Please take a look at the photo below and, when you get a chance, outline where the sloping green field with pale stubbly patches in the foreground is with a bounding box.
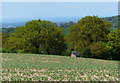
[1,53,119,81]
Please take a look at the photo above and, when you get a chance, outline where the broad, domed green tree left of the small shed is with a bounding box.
[4,20,65,54]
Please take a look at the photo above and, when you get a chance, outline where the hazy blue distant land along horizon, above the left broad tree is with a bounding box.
[0,17,81,28]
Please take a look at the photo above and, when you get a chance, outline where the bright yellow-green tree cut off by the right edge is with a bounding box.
[107,28,120,60]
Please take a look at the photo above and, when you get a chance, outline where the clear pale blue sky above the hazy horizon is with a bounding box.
[2,2,118,22]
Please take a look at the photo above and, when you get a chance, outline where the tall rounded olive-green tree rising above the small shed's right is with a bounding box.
[67,16,112,53]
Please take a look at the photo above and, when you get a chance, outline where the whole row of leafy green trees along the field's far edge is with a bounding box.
[2,16,120,60]
